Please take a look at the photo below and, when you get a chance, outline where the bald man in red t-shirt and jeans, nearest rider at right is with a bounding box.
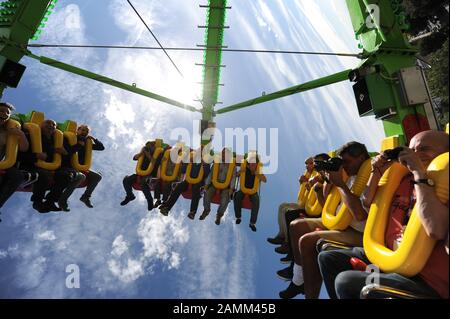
[318,131,449,299]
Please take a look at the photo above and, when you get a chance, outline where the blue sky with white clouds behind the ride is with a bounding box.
[0,0,383,298]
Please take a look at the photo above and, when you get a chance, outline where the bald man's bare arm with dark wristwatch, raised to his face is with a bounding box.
[399,148,449,240]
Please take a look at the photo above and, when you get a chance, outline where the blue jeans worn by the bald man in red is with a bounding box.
[318,247,439,299]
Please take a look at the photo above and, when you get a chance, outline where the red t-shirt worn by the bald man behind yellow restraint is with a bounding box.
[385,174,449,298]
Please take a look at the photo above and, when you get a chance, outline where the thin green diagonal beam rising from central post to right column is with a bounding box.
[216,70,352,114]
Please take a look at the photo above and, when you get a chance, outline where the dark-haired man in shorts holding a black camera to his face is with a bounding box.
[279,142,370,299]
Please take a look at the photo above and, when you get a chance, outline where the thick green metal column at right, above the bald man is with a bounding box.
[346,0,432,142]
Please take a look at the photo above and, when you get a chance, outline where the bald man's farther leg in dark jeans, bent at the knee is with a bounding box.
[317,247,370,299]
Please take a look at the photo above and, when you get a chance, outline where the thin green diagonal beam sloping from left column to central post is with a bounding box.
[27,52,200,112]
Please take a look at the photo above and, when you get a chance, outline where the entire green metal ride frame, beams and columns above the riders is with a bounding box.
[0,0,436,145]
